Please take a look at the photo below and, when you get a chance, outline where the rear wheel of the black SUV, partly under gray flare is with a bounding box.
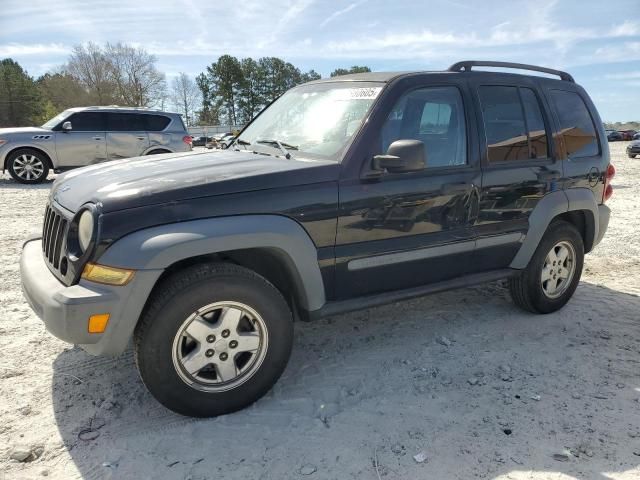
[509,220,584,313]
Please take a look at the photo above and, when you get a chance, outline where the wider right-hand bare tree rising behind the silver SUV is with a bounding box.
[105,43,166,107]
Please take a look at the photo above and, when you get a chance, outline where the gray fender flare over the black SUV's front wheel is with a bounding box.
[98,215,325,311]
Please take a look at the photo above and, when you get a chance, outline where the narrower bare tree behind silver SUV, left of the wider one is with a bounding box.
[65,42,117,105]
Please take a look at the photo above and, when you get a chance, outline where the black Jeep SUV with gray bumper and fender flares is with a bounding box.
[21,62,614,416]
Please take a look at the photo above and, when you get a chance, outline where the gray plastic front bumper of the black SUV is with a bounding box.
[20,238,162,355]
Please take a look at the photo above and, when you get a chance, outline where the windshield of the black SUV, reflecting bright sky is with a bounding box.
[237,82,382,161]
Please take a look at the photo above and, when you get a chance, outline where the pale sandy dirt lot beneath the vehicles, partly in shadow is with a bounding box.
[0,143,640,480]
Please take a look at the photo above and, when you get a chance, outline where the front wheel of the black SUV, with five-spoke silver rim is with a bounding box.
[134,263,293,417]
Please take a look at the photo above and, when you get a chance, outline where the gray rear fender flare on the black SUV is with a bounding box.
[509,188,600,269]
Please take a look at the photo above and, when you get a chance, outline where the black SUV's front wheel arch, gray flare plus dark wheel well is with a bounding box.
[98,215,325,311]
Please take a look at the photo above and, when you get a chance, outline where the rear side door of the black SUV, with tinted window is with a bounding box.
[472,77,562,272]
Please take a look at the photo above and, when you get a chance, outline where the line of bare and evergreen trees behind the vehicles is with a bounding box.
[0,43,371,127]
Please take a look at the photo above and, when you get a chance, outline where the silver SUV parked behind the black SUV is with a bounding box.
[0,107,191,183]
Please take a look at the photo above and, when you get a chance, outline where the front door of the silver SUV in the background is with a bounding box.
[56,112,107,168]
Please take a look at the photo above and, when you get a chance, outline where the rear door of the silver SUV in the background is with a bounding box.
[107,112,149,160]
